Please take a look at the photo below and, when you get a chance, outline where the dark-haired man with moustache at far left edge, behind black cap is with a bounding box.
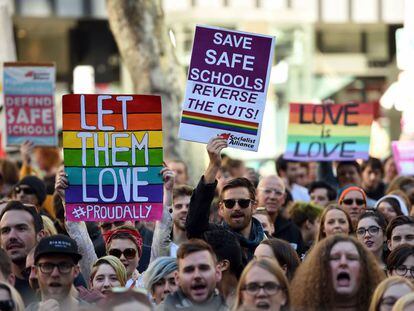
[0,201,44,304]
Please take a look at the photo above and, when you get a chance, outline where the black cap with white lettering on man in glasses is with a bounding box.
[34,234,82,263]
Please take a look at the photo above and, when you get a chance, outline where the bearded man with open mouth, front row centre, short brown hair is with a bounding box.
[157,239,228,311]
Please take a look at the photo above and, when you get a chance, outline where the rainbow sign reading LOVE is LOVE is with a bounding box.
[283,103,373,161]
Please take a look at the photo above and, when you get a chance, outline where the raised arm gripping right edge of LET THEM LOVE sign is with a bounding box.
[150,167,175,262]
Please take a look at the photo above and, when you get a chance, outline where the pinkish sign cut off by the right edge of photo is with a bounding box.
[392,141,414,175]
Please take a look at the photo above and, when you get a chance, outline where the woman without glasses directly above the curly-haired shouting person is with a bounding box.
[315,204,353,243]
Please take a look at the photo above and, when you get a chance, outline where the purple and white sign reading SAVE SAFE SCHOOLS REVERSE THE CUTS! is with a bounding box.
[179,26,275,151]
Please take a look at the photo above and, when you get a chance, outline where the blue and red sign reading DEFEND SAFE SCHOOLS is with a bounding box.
[3,62,57,146]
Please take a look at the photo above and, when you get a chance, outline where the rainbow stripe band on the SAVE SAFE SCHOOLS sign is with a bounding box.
[181,110,259,135]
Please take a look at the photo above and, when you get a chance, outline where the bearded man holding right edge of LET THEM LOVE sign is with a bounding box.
[151,167,193,262]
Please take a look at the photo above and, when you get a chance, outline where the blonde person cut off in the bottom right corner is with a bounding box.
[369,276,414,311]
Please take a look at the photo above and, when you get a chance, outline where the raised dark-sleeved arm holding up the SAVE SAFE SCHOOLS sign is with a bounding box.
[185,137,227,239]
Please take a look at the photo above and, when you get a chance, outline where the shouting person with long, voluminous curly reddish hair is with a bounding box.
[291,235,385,311]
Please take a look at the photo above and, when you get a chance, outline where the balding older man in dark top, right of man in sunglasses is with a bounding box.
[257,175,304,256]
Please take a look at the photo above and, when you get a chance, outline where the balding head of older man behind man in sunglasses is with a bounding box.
[257,175,286,219]
